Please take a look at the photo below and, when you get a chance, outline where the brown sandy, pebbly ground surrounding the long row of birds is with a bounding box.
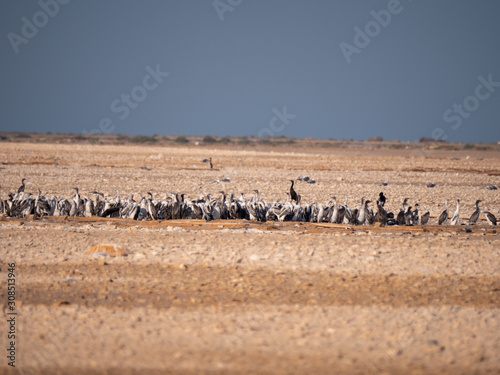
[0,143,500,374]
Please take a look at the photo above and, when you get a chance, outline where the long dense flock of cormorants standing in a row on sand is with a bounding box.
[0,179,497,225]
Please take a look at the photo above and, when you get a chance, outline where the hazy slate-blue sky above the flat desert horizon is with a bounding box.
[0,0,500,142]
